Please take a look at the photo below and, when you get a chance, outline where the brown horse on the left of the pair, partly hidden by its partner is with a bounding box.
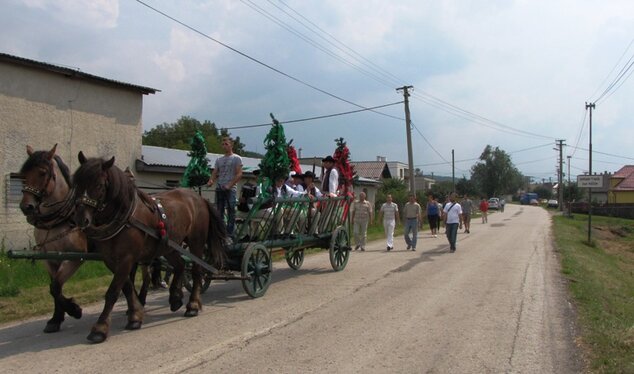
[20,144,88,333]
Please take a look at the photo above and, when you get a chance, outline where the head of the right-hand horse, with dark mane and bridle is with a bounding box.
[73,151,114,230]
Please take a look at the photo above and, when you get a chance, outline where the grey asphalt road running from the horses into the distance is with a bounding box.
[0,205,582,373]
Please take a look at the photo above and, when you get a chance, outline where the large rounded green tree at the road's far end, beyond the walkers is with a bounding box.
[471,145,522,197]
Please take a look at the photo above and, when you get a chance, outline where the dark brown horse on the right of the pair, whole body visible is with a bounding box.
[73,152,227,343]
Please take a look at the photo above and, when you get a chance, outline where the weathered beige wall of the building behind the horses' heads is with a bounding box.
[0,62,143,249]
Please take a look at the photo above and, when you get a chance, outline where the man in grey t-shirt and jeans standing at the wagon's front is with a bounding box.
[207,137,242,236]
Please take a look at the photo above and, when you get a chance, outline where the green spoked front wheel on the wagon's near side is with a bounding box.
[242,243,273,297]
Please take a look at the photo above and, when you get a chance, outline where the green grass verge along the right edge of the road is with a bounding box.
[553,215,634,373]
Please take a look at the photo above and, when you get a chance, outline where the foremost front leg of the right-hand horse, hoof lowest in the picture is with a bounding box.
[86,263,136,343]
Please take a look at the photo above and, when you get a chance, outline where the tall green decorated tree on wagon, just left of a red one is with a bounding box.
[260,113,290,183]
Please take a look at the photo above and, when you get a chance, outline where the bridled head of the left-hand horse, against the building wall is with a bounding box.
[20,144,69,219]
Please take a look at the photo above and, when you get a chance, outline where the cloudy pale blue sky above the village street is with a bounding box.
[0,0,634,182]
